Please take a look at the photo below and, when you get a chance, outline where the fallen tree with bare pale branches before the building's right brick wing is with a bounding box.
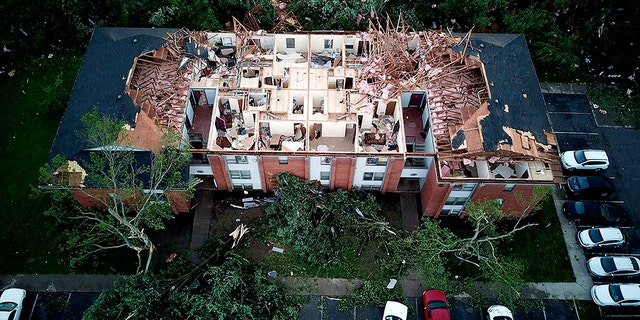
[368,186,551,306]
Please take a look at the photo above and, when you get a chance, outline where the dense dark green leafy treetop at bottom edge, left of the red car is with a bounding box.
[83,225,303,320]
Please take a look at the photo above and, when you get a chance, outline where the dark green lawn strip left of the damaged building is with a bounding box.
[0,57,82,274]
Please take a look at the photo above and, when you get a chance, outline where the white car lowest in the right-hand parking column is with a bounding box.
[591,283,640,307]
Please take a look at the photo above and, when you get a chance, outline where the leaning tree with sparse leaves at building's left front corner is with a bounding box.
[41,111,194,272]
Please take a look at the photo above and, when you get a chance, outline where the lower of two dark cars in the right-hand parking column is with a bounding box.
[562,201,620,223]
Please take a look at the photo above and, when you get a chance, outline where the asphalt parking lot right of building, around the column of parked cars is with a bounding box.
[545,94,640,317]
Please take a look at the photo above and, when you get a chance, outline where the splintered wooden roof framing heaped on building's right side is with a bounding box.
[358,16,490,151]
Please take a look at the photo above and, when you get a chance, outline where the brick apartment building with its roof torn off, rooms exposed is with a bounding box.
[51,17,560,217]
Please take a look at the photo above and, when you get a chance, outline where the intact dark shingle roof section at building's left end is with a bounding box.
[49,28,175,160]
